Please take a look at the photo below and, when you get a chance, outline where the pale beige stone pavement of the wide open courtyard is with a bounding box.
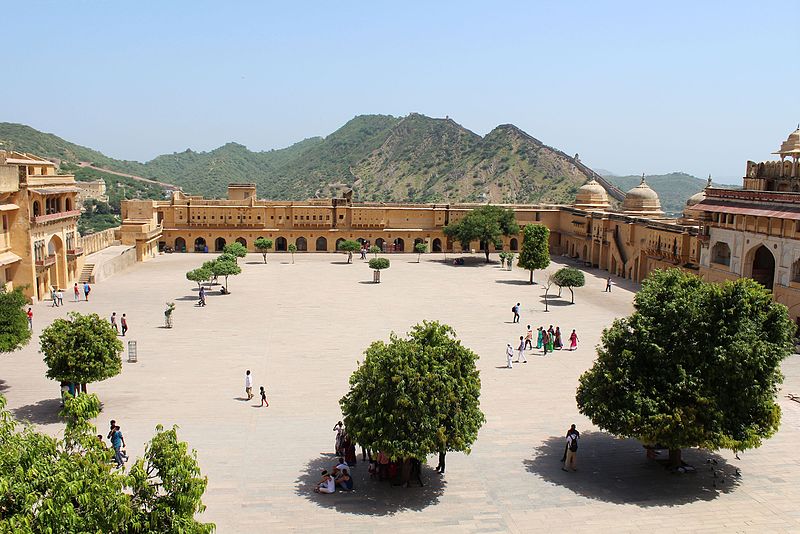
[0,253,800,533]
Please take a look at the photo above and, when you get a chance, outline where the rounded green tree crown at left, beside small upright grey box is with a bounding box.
[39,312,123,392]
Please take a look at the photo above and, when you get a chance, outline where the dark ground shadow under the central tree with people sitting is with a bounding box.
[295,454,447,516]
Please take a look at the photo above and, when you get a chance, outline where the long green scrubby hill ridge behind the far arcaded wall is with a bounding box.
[0,114,586,206]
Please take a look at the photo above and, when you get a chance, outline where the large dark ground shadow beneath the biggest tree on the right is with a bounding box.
[523,432,739,507]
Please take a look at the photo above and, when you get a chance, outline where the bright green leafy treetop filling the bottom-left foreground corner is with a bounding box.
[0,395,215,534]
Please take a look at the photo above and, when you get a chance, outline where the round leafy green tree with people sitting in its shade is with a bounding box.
[339,321,485,486]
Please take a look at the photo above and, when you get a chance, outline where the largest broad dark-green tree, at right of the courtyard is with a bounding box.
[576,269,794,467]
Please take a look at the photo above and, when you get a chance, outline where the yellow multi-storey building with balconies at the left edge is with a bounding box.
[0,150,83,300]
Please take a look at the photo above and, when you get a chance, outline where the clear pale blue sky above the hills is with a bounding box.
[0,0,800,183]
